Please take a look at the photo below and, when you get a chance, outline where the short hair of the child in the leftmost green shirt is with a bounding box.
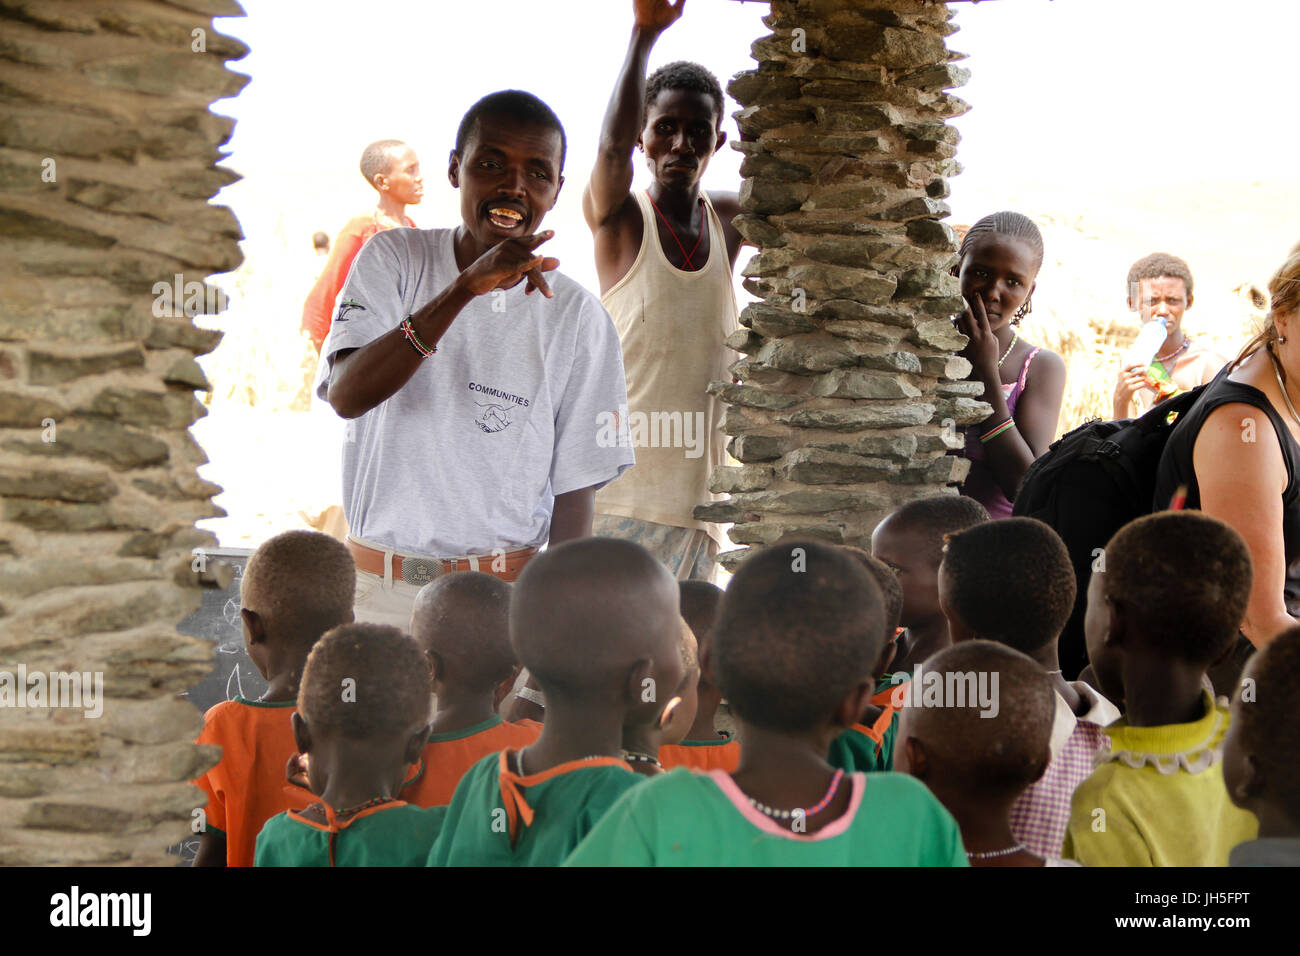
[298,624,432,740]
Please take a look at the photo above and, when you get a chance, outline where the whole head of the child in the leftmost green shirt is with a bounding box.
[293,624,432,809]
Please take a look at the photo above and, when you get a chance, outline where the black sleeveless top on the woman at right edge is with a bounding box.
[1153,367,1300,617]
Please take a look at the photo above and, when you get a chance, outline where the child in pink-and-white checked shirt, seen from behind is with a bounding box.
[939,518,1119,858]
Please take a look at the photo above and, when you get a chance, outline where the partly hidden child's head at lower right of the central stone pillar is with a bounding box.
[871,494,988,627]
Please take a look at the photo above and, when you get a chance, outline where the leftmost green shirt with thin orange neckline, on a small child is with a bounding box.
[254,803,447,866]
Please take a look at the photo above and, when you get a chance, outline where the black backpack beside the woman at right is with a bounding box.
[1011,385,1205,680]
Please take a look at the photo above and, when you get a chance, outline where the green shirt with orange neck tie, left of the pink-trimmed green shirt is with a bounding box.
[429,753,645,866]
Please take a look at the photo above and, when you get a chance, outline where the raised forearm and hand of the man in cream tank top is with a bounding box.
[582,0,686,232]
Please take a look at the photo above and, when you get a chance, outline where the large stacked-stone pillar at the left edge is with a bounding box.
[0,0,247,865]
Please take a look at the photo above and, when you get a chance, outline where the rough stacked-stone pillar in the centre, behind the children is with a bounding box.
[696,0,991,567]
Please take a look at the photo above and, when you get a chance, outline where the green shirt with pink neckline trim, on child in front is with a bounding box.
[566,769,967,866]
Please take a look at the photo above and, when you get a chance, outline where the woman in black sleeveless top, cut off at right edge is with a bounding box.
[1154,246,1300,658]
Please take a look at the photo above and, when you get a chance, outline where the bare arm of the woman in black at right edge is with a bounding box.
[1192,403,1297,648]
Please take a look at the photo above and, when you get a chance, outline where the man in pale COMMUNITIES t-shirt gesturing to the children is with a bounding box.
[319,91,634,628]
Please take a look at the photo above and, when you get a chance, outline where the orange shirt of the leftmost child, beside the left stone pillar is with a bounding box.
[194,697,316,866]
